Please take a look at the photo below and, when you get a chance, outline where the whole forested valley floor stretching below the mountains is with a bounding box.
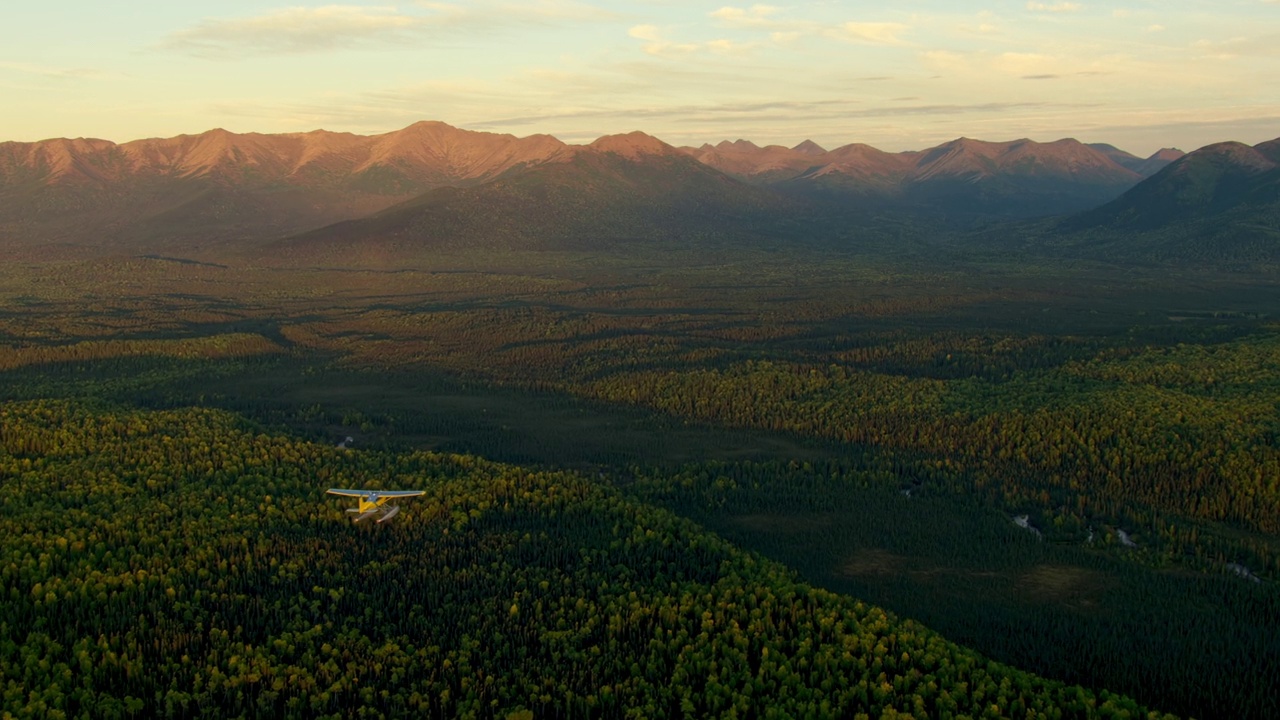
[0,249,1280,717]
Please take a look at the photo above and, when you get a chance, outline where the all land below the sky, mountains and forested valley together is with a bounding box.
[0,123,1280,720]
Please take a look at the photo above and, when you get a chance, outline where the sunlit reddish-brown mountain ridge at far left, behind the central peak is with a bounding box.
[0,123,568,253]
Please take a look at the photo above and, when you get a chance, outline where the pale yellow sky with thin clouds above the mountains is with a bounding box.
[0,0,1280,155]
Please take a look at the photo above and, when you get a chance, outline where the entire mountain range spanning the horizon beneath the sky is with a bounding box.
[0,122,1280,266]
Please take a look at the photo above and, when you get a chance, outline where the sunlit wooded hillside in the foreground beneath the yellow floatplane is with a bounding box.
[0,401,1172,717]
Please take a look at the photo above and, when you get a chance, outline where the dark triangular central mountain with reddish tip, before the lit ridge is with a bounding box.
[265,132,805,258]
